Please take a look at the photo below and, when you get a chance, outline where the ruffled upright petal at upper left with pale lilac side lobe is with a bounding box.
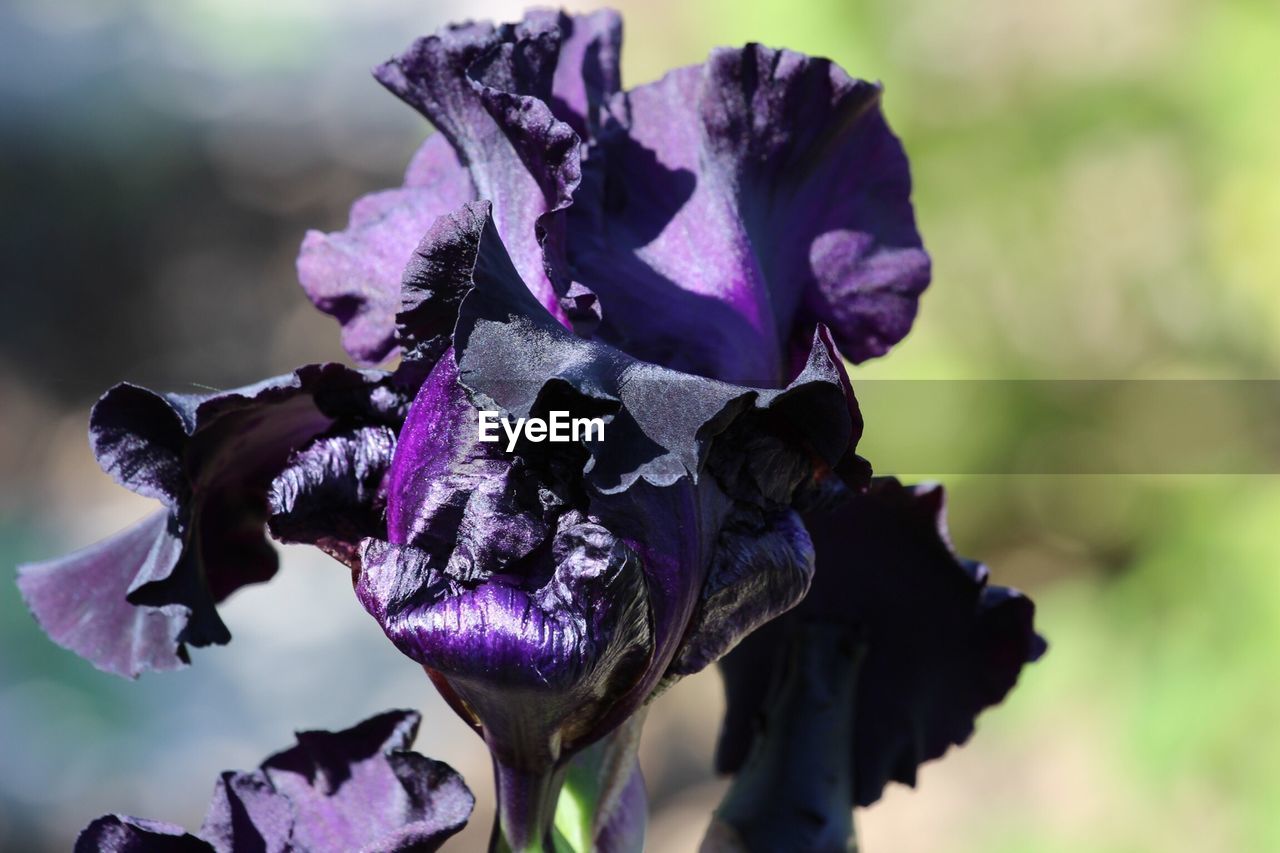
[298,10,622,364]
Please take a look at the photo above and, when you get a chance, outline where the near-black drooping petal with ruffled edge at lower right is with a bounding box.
[716,478,1046,806]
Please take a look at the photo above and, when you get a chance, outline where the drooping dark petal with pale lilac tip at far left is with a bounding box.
[18,365,393,678]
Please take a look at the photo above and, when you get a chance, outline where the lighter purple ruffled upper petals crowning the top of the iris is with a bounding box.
[300,12,929,387]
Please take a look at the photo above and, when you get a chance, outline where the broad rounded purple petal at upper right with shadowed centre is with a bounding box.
[568,45,929,387]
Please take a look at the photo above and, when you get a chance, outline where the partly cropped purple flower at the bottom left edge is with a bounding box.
[76,711,475,853]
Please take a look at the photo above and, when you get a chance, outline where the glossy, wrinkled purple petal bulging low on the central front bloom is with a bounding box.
[356,512,652,766]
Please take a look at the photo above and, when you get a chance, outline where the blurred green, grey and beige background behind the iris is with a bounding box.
[0,0,1280,853]
